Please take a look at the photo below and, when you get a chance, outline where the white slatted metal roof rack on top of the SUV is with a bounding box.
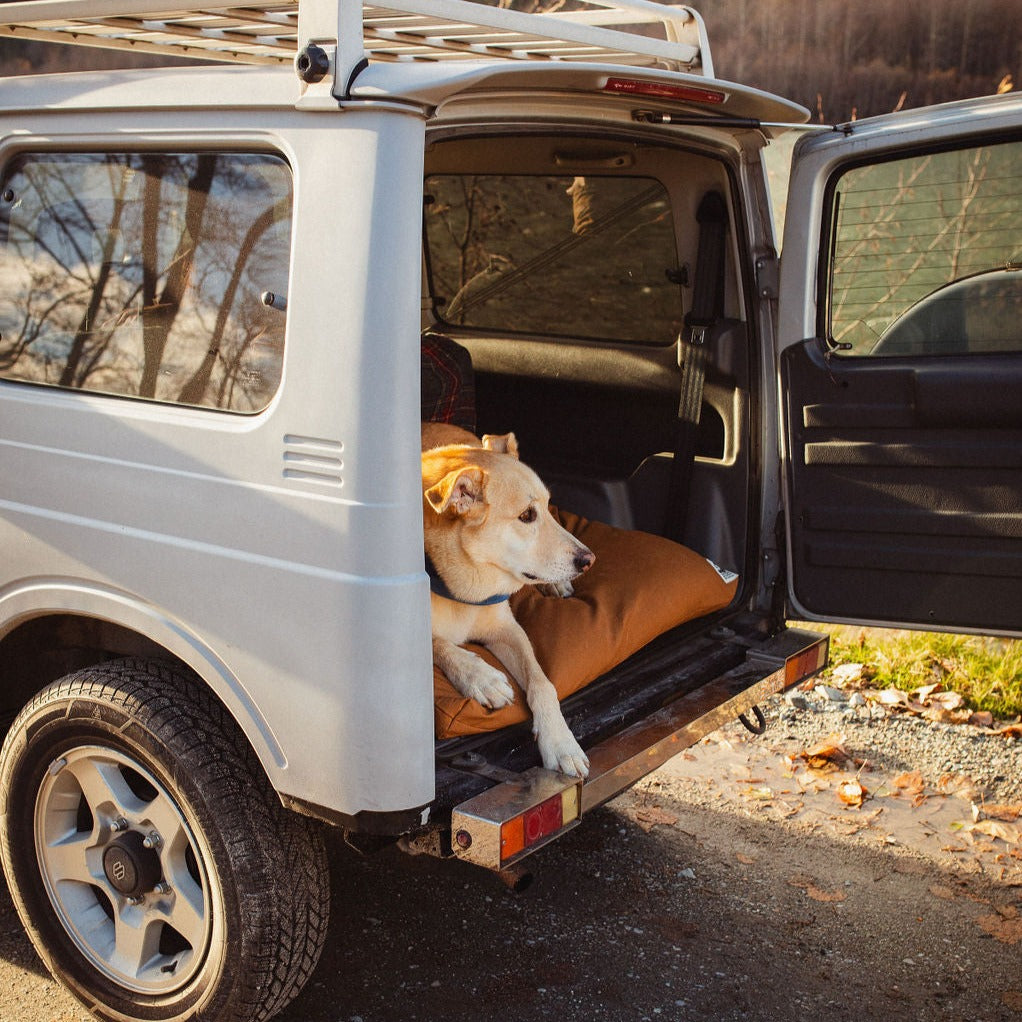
[0,0,713,95]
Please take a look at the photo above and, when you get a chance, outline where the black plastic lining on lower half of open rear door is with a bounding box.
[782,340,1022,632]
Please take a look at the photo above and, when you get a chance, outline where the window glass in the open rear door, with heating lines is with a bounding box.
[827,141,1022,357]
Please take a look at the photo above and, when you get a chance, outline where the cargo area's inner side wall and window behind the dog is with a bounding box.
[416,129,750,571]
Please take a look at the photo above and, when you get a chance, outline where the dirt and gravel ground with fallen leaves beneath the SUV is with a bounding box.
[0,733,1022,1022]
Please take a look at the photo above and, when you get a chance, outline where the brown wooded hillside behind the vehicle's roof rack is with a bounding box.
[0,0,1022,122]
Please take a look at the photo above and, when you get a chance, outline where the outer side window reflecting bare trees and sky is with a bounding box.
[0,152,291,412]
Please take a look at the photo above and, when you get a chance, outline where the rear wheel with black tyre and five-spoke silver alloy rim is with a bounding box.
[0,660,329,1022]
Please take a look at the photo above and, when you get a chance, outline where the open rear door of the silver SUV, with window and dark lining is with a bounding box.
[779,94,1022,635]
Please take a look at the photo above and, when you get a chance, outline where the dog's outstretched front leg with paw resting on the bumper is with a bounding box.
[485,619,589,777]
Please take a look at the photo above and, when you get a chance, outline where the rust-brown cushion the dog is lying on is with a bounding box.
[433,511,738,738]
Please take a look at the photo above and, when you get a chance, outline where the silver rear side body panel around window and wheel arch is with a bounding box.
[0,99,433,814]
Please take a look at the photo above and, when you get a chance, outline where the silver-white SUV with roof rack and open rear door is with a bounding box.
[0,0,1022,1022]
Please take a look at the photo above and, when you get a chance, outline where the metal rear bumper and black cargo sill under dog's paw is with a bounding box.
[281,629,829,850]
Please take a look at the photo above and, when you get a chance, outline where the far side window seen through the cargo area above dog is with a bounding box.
[425,175,682,344]
